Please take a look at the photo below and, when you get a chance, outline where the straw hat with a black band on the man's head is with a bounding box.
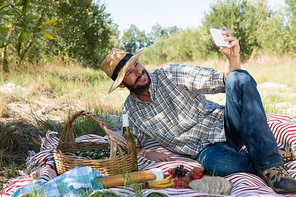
[101,48,144,93]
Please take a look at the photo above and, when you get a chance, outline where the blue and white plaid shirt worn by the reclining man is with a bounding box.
[122,64,226,158]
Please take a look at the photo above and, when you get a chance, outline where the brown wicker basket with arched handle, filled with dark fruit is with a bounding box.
[53,111,133,175]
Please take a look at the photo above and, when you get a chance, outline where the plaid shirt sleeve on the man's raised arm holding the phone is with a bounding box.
[164,64,225,94]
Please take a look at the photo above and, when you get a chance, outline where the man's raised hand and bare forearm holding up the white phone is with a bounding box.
[219,26,241,83]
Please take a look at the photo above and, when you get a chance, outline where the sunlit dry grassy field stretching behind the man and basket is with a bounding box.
[0,56,296,189]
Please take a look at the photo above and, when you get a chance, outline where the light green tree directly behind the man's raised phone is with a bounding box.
[202,0,272,60]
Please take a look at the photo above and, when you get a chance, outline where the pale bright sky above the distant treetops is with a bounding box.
[100,0,285,37]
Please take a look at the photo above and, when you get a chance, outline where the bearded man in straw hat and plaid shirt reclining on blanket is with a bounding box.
[101,27,296,193]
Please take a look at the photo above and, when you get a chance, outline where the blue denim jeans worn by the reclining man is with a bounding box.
[197,70,283,176]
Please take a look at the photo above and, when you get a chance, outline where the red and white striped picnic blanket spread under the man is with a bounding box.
[0,114,296,197]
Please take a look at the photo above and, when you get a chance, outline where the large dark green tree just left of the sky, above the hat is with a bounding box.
[44,0,115,68]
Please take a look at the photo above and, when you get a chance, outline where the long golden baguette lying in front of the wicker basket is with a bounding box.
[99,170,156,189]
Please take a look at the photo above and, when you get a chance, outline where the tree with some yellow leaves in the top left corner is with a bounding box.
[0,0,55,72]
